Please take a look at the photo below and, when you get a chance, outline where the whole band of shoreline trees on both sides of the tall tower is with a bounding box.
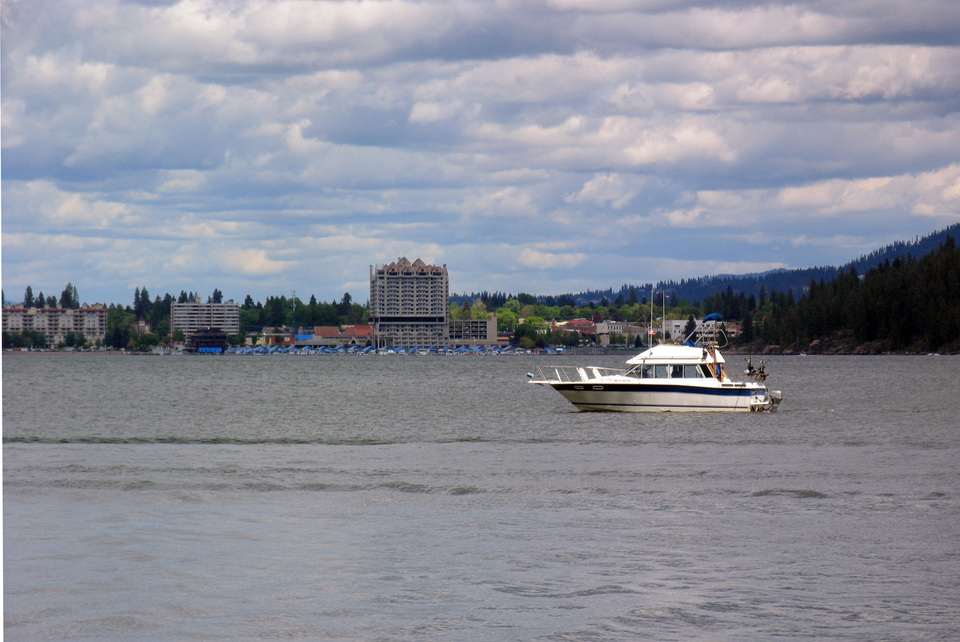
[4,236,960,352]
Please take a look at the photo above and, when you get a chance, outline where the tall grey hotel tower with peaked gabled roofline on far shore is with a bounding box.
[370,257,450,347]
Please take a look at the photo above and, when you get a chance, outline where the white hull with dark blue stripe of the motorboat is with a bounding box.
[550,382,775,412]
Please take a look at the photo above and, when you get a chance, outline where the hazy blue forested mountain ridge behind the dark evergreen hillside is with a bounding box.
[450,222,960,306]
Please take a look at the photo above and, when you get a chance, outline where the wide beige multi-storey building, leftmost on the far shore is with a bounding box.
[3,303,107,346]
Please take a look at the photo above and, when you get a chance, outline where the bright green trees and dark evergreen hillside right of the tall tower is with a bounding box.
[492,237,960,353]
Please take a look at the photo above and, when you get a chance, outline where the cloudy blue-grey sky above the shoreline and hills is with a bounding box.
[0,0,960,304]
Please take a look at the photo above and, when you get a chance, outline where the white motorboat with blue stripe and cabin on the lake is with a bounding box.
[527,318,782,412]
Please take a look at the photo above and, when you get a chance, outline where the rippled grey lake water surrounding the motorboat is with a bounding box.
[2,353,960,640]
